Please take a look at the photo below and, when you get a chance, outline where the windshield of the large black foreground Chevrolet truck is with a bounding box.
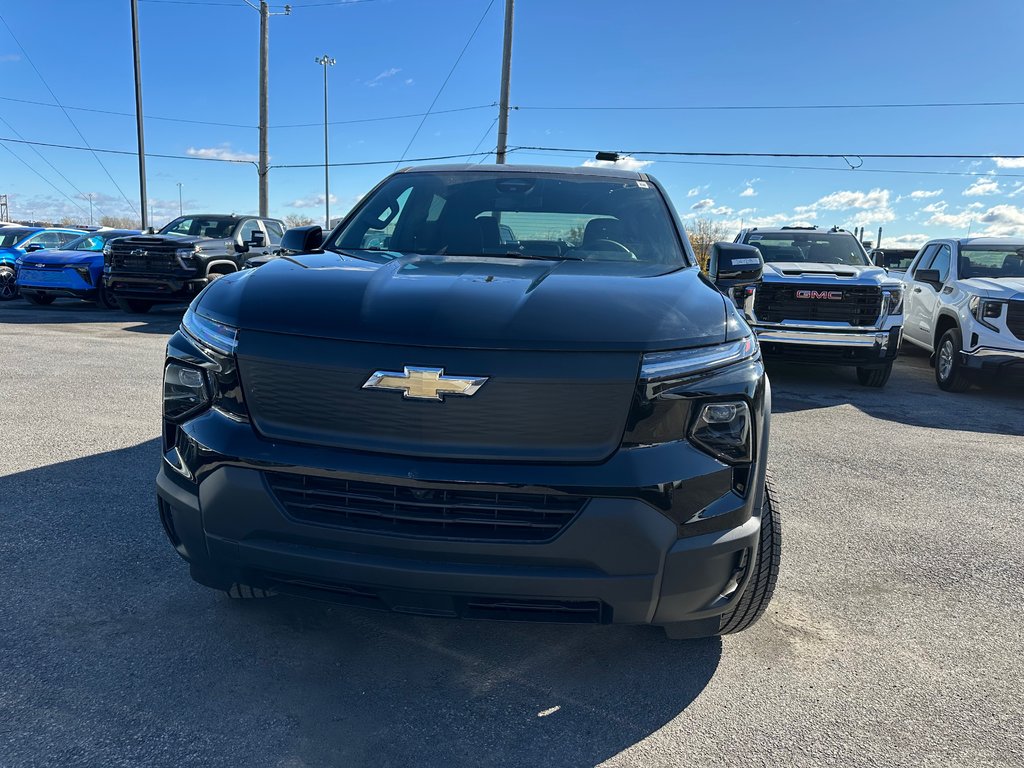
[326,171,686,269]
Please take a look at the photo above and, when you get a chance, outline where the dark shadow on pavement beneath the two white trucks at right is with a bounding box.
[767,345,1024,435]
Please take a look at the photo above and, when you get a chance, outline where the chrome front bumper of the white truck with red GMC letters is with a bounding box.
[754,326,903,366]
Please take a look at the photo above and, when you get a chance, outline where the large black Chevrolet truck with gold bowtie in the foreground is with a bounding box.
[157,166,780,637]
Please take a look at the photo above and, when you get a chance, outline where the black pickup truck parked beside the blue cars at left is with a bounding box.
[103,214,285,312]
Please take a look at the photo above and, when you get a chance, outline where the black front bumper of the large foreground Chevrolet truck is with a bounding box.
[157,376,770,631]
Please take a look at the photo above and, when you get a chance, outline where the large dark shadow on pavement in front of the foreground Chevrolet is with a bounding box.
[0,440,722,766]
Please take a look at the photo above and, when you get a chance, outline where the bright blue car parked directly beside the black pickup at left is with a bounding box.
[17,229,139,309]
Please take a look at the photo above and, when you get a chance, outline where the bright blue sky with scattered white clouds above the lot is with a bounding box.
[0,0,1024,247]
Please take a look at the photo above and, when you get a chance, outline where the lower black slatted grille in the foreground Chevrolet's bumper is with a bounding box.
[264,472,586,542]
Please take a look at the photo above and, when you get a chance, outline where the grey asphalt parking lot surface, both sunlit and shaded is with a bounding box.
[0,301,1024,768]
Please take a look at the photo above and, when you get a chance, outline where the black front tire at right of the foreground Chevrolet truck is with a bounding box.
[665,477,782,640]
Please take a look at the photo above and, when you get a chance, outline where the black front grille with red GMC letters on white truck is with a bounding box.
[754,283,882,326]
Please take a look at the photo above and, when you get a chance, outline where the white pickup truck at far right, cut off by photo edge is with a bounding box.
[903,238,1024,392]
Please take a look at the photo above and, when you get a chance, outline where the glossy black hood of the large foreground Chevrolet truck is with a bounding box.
[195,253,729,351]
